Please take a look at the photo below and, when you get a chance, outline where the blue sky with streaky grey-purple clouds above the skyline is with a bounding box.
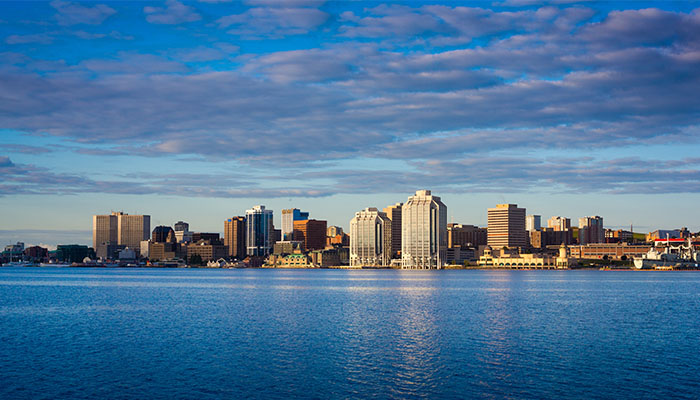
[0,0,700,247]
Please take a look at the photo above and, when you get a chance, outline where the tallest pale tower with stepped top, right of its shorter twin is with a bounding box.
[401,190,447,269]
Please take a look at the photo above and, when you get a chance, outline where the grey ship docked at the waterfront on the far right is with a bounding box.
[634,238,700,269]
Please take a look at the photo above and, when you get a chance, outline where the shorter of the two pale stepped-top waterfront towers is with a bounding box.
[350,207,391,267]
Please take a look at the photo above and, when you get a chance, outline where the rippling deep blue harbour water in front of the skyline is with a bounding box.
[0,268,700,399]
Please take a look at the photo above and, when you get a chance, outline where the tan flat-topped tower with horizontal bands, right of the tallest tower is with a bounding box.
[488,204,527,249]
